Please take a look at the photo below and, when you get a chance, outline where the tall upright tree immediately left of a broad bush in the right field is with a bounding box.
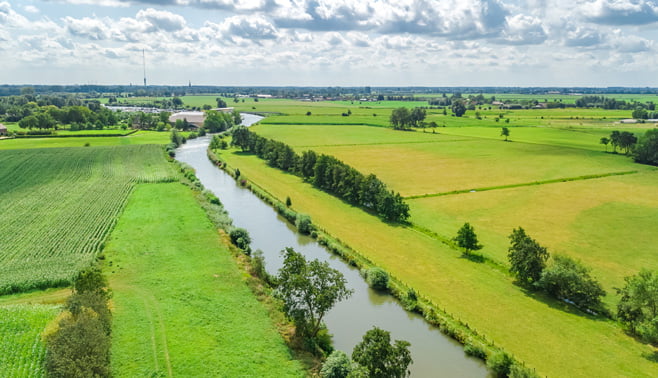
[507,227,549,285]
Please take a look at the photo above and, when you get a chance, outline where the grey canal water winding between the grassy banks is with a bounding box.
[176,114,488,377]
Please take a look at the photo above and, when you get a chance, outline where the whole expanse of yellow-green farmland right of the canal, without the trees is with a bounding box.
[213,101,658,376]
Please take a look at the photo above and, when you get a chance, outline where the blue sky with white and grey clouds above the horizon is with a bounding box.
[0,0,658,87]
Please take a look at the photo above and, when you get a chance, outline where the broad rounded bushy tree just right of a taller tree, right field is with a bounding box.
[537,255,605,309]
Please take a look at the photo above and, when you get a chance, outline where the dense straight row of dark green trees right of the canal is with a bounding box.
[231,127,409,222]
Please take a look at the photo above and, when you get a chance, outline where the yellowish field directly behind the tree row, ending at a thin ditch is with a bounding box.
[253,124,647,196]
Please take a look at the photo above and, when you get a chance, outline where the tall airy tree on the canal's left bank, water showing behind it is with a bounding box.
[275,248,353,338]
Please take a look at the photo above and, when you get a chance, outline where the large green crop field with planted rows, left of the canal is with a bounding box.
[0,145,174,294]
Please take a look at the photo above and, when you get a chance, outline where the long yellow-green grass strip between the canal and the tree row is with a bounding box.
[221,152,655,377]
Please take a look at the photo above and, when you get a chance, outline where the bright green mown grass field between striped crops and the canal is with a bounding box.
[105,183,306,377]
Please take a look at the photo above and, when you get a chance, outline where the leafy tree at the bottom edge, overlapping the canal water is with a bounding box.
[352,327,412,378]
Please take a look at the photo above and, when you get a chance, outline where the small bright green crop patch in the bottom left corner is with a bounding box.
[0,305,59,378]
